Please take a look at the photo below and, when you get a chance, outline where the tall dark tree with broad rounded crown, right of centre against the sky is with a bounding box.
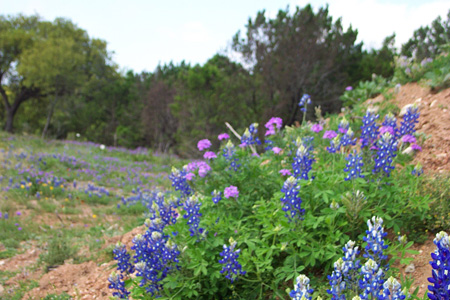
[233,5,361,124]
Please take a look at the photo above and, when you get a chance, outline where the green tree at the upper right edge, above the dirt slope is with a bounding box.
[401,10,450,61]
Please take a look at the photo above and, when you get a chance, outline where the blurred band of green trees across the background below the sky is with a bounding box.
[0,5,450,156]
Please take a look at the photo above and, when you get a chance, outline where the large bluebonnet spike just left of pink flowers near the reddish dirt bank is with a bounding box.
[372,132,397,177]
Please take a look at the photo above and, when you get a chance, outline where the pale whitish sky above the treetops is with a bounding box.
[0,0,450,73]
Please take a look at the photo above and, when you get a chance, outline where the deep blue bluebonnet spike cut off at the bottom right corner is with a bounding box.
[428,231,450,300]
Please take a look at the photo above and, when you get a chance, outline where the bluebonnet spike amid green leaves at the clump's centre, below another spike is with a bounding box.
[281,176,305,221]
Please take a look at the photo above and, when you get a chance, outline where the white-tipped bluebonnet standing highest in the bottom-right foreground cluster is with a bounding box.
[363,216,388,265]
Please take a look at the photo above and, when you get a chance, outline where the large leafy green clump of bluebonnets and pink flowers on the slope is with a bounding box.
[109,95,446,299]
